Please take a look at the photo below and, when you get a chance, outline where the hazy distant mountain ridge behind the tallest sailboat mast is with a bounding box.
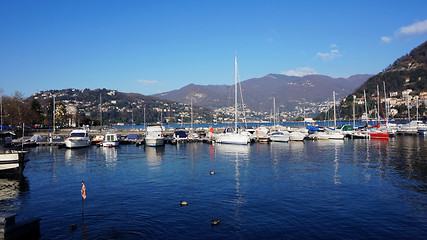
[153,74,372,111]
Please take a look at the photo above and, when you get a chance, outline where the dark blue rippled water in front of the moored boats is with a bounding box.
[0,136,427,239]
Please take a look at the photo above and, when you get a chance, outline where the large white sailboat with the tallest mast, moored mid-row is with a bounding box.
[215,57,251,145]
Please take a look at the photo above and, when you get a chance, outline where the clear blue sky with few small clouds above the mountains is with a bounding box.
[0,0,427,97]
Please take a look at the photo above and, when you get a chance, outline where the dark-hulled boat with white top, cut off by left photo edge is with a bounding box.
[0,150,28,174]
